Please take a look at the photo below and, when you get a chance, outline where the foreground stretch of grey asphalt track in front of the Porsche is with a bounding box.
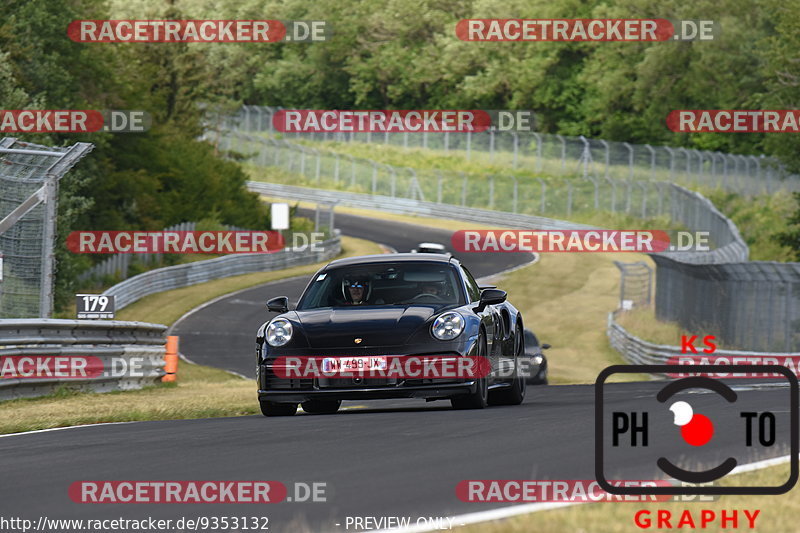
[0,383,785,532]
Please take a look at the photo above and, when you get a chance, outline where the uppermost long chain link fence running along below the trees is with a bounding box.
[219,106,800,195]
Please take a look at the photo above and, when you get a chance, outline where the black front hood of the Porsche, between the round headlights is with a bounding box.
[297,305,437,348]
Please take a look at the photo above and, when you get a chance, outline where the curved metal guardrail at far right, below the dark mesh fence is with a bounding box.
[606,311,800,372]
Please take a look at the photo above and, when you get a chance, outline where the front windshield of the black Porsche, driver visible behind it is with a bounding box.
[297,262,464,311]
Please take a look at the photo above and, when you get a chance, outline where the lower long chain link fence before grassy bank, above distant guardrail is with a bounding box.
[205,130,677,225]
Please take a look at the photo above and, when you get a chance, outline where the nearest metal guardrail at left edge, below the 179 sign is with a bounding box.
[0,318,167,400]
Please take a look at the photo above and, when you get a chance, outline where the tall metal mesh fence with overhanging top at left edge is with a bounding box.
[0,137,93,318]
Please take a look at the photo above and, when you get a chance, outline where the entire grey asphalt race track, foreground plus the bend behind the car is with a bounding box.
[0,211,788,532]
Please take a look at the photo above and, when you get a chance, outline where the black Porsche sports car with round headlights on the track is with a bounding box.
[256,253,542,416]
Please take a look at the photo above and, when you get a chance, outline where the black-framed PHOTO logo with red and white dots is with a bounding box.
[595,365,800,495]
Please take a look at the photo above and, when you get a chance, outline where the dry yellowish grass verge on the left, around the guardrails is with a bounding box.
[0,237,381,434]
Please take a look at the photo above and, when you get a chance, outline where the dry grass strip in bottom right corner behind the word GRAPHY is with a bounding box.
[458,464,800,533]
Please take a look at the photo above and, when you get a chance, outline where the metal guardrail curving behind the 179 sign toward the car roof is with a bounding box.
[103,236,341,309]
